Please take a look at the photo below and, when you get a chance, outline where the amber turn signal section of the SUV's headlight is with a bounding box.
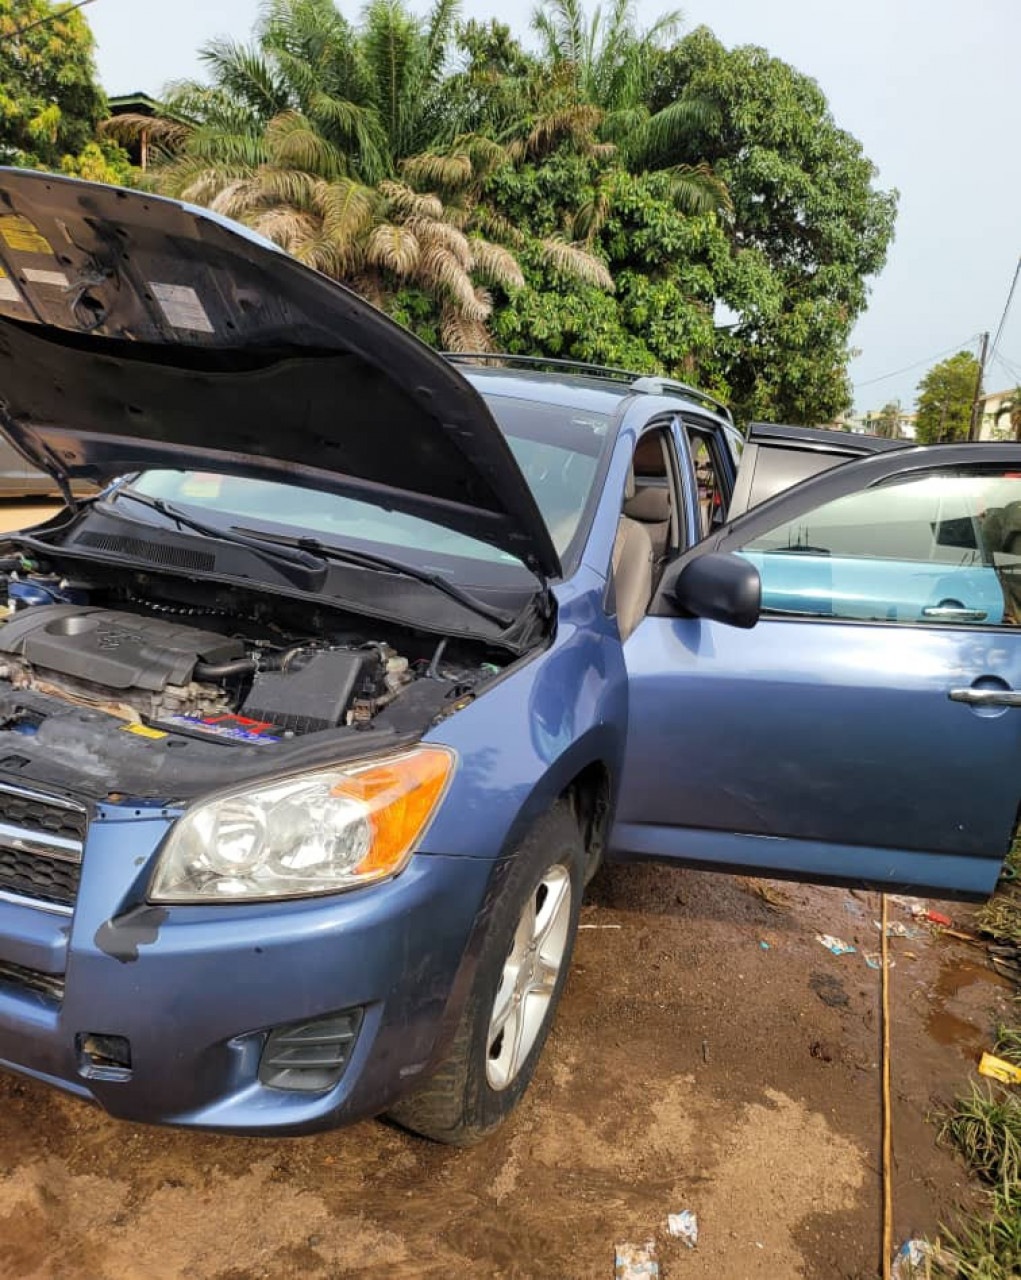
[331,746,454,879]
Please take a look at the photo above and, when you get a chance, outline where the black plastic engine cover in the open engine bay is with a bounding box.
[0,604,244,694]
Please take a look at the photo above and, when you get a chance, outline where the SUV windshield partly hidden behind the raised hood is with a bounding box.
[124,396,610,580]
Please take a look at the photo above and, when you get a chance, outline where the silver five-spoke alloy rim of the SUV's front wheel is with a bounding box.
[486,865,571,1091]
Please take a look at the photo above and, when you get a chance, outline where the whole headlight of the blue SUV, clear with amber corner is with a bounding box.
[148,746,454,902]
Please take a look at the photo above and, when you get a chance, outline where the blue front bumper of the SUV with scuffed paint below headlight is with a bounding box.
[0,813,494,1134]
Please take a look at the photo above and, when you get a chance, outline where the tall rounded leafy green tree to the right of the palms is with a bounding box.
[650,27,896,422]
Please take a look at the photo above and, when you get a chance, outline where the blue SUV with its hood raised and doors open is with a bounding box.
[0,170,1021,1144]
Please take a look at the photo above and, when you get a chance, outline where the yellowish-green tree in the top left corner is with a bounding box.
[0,0,115,169]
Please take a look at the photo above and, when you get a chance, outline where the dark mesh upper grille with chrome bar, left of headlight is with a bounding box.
[0,783,88,910]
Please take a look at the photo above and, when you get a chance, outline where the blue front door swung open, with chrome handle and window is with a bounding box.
[612,445,1021,896]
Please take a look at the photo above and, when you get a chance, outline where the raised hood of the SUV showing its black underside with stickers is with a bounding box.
[0,168,560,577]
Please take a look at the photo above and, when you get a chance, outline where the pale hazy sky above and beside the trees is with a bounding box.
[86,0,1021,410]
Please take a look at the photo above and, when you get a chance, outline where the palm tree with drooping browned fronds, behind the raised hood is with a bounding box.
[107,0,613,351]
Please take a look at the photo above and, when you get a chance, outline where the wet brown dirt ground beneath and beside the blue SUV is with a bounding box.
[0,867,1009,1280]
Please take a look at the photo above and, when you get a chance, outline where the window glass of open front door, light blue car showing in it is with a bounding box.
[742,471,1021,626]
